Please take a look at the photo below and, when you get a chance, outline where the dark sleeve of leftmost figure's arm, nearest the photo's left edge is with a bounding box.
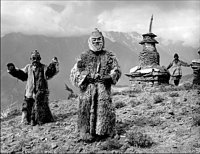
[7,65,28,81]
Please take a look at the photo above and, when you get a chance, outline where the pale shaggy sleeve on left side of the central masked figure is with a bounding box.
[70,62,88,88]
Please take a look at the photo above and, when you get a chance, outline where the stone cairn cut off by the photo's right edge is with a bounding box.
[192,48,200,85]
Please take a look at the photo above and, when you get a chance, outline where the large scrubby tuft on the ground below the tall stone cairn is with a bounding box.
[126,127,154,148]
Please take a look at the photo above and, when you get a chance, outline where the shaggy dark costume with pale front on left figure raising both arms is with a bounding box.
[8,50,58,125]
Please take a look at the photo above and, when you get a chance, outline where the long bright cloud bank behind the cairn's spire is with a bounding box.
[98,4,200,47]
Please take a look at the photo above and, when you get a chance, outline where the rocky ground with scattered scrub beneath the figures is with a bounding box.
[1,83,200,153]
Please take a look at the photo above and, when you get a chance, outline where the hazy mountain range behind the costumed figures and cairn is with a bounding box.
[1,31,198,110]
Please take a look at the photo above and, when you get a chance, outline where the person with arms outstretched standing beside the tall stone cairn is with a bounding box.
[167,54,191,86]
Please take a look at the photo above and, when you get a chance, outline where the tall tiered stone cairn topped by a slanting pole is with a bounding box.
[125,15,170,89]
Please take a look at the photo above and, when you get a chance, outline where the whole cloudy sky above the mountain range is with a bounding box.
[1,0,200,48]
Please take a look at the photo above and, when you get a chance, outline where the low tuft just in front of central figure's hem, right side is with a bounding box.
[100,138,122,151]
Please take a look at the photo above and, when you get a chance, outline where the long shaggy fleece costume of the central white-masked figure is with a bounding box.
[70,28,121,140]
